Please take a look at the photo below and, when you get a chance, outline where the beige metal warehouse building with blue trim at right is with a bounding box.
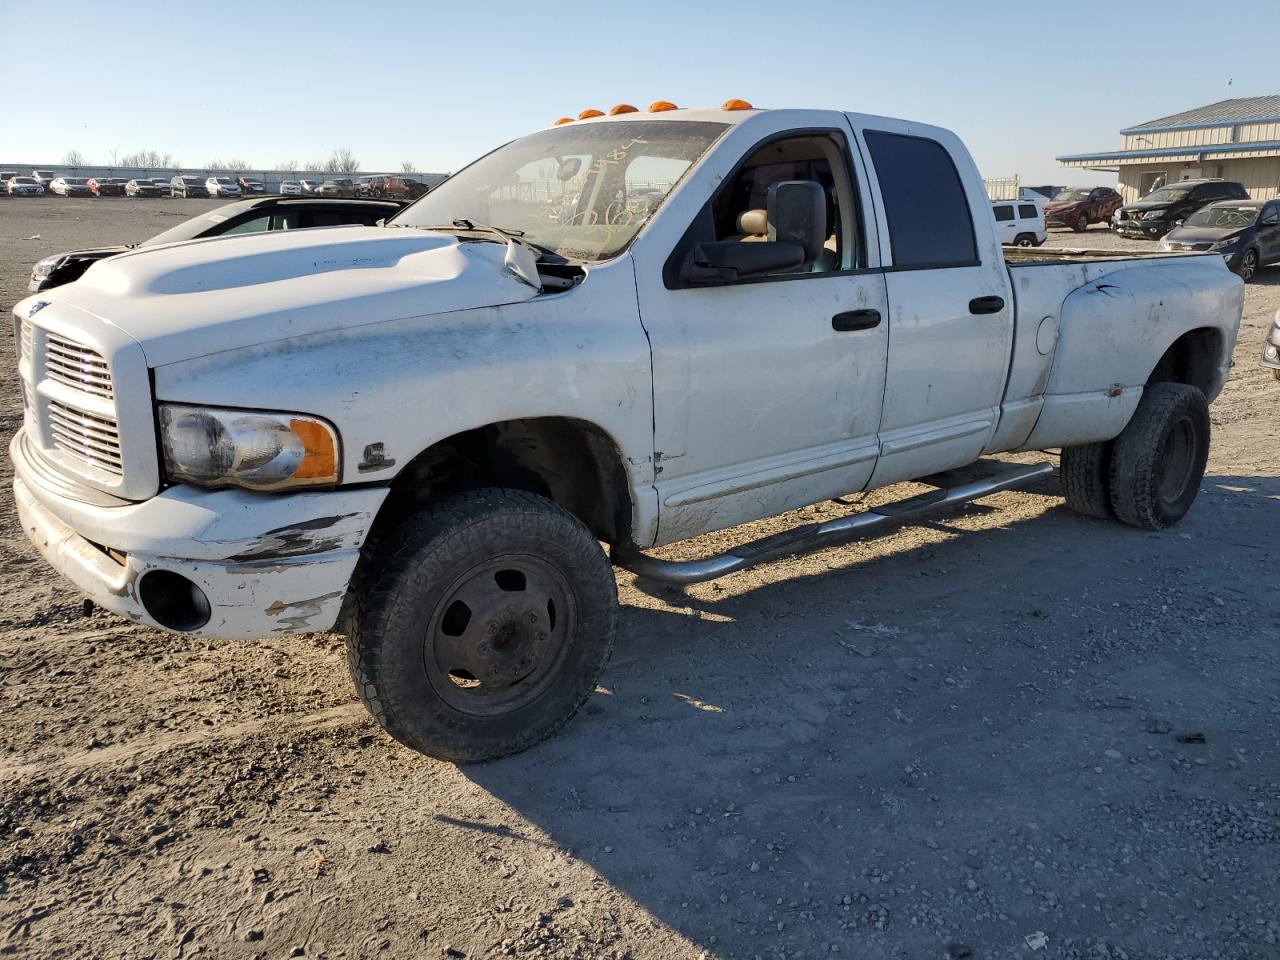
[1057,95,1280,204]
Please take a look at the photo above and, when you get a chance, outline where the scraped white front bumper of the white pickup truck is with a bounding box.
[9,430,387,639]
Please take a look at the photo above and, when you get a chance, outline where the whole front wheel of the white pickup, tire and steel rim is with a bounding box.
[347,489,618,763]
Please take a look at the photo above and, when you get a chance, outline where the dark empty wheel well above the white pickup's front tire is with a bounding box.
[376,417,631,544]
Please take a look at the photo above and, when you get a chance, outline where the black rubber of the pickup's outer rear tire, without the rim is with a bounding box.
[1108,383,1210,530]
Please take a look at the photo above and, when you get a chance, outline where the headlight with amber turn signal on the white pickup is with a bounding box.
[160,403,339,490]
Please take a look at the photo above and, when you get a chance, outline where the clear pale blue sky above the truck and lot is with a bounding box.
[0,0,1280,183]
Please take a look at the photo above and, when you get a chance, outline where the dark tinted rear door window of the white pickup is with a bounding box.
[865,131,978,270]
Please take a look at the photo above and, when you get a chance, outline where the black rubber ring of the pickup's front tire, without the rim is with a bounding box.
[347,488,618,763]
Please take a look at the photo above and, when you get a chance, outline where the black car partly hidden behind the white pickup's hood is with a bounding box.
[27,196,404,293]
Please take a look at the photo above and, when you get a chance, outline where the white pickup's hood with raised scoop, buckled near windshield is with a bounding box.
[32,227,538,366]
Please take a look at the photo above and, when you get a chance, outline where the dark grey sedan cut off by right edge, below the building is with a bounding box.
[1161,200,1280,283]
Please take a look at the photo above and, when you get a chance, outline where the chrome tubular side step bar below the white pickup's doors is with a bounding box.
[614,461,1053,584]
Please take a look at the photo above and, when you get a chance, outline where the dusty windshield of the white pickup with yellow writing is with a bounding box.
[390,120,726,261]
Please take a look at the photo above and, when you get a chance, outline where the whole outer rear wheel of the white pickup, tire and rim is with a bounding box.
[1108,383,1210,530]
